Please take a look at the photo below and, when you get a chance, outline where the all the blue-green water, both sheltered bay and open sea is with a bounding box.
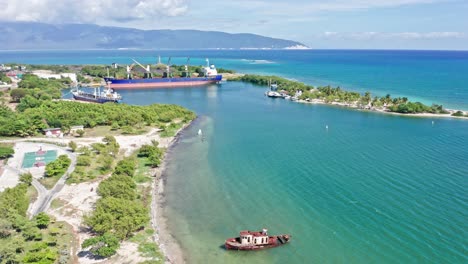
[0,50,468,263]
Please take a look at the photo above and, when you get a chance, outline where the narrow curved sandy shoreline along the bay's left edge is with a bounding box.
[150,117,198,264]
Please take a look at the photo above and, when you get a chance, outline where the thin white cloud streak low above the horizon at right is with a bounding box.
[318,32,468,40]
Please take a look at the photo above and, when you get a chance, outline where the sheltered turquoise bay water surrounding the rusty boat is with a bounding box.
[119,83,468,263]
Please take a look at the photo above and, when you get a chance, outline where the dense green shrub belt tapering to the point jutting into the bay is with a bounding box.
[0,99,195,137]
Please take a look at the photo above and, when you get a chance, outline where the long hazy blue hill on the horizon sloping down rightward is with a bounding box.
[0,21,305,50]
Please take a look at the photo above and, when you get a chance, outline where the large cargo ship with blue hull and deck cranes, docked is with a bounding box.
[104,59,223,90]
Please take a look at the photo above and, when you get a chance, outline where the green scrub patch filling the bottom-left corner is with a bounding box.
[0,183,71,264]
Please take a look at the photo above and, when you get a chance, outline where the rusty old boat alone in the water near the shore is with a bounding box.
[224,228,291,250]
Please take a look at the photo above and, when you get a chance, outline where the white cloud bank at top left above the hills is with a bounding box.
[0,0,188,23]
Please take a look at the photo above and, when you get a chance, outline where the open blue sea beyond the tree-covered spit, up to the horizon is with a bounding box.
[0,50,468,110]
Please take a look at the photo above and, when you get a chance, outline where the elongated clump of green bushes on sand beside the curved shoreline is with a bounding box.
[82,154,157,257]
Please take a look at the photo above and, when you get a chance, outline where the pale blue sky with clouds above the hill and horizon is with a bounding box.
[0,0,468,50]
